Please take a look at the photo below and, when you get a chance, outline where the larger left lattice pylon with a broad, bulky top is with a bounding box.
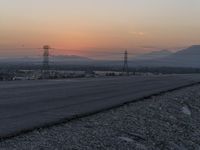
[42,45,50,79]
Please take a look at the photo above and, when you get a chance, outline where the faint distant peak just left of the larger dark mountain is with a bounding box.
[133,50,173,60]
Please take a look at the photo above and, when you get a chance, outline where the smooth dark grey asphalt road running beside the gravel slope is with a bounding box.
[0,75,200,138]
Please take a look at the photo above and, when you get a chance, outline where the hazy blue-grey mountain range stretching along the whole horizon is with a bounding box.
[0,45,200,68]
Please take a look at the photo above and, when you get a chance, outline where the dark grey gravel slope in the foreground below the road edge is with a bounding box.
[0,85,200,150]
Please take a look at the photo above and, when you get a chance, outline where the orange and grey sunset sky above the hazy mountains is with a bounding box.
[0,0,200,56]
